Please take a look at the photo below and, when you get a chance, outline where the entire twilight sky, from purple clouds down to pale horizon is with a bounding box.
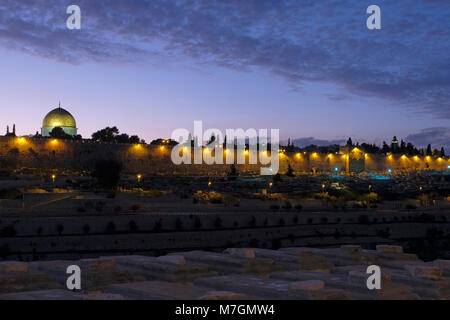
[0,0,450,153]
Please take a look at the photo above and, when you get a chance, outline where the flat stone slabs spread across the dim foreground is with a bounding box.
[0,245,450,300]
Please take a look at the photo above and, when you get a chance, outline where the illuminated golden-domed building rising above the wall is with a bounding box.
[41,104,77,137]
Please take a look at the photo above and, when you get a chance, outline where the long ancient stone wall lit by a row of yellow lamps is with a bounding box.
[0,137,450,175]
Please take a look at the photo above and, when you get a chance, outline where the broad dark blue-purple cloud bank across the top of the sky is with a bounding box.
[0,0,450,119]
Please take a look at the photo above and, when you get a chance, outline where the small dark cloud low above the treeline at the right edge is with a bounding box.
[405,127,450,153]
